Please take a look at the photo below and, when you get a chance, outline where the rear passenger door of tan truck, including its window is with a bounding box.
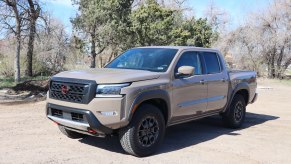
[202,52,228,111]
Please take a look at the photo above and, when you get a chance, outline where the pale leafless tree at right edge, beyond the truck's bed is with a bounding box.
[219,0,291,78]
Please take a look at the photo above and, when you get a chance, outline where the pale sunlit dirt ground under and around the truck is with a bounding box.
[0,79,291,164]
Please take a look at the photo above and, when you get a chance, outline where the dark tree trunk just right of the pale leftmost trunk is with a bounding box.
[25,20,35,77]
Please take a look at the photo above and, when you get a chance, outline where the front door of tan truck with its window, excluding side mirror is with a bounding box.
[172,51,207,121]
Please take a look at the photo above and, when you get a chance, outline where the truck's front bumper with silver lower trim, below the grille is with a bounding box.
[46,103,113,135]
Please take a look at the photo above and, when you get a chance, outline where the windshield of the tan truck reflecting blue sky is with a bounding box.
[105,48,178,72]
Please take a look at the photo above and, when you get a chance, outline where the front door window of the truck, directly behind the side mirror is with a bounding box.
[175,51,202,75]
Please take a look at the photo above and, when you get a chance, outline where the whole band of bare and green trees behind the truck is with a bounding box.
[0,0,291,82]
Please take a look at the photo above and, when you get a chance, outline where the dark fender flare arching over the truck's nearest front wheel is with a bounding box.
[128,89,171,122]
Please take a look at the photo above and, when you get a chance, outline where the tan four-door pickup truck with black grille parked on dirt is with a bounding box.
[46,46,257,157]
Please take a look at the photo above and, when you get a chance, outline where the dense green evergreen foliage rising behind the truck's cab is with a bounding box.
[72,0,215,67]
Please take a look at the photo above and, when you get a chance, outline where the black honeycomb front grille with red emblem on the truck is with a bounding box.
[50,81,88,103]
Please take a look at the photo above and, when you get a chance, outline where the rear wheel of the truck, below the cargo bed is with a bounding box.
[222,94,246,129]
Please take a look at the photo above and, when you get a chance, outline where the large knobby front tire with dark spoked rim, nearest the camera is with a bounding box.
[119,104,166,157]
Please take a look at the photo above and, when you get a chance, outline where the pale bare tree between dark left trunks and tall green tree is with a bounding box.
[33,15,69,75]
